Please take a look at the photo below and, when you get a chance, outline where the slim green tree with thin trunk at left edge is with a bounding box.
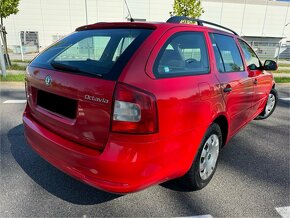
[0,0,20,66]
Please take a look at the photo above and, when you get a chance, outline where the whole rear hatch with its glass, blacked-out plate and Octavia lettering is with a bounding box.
[26,28,152,150]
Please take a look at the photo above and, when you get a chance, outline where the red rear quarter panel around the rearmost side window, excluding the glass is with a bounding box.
[120,27,224,175]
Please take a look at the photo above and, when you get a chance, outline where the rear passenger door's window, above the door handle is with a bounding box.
[210,34,245,72]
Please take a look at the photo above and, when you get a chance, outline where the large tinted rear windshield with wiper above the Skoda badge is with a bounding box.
[30,29,152,80]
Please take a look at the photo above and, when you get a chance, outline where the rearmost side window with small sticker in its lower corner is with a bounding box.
[153,32,209,77]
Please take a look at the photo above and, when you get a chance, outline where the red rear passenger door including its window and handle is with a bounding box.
[210,33,253,135]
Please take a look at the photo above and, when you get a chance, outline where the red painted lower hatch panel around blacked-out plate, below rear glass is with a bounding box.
[26,67,116,150]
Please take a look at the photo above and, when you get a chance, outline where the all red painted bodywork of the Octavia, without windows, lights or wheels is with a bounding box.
[23,23,273,193]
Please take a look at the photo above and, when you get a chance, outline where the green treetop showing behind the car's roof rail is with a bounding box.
[170,0,204,18]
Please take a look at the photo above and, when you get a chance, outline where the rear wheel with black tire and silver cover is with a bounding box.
[180,123,222,191]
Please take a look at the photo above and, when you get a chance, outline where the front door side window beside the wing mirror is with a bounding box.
[238,39,261,70]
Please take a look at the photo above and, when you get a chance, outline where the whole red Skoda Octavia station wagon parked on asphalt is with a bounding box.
[23,17,277,193]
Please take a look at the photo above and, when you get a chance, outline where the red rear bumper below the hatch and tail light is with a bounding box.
[23,105,189,193]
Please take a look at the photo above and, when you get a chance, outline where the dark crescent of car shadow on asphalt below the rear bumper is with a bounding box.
[8,124,121,205]
